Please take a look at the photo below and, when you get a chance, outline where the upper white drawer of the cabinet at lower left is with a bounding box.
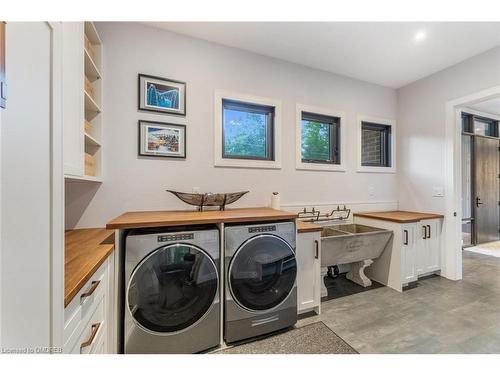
[64,260,108,348]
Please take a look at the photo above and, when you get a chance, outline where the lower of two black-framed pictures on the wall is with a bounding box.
[139,120,186,158]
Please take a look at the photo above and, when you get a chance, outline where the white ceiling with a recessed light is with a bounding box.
[147,22,500,88]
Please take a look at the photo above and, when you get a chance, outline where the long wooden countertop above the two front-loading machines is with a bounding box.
[106,207,298,229]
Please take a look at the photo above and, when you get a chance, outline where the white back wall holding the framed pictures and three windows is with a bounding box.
[66,23,398,228]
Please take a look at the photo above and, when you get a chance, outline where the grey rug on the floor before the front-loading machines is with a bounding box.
[216,322,357,354]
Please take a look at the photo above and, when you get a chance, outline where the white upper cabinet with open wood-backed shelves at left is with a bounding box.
[62,22,103,182]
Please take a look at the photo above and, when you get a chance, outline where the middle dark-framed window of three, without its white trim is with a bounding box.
[301,112,340,164]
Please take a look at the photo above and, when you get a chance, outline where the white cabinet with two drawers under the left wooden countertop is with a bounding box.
[63,256,113,354]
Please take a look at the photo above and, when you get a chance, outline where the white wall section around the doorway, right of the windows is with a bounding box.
[398,47,500,213]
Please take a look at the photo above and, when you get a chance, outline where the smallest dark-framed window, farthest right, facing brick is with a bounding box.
[361,121,392,167]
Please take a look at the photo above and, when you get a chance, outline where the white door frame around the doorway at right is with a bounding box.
[448,86,500,280]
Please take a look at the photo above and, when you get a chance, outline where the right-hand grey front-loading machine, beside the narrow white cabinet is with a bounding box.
[224,222,297,343]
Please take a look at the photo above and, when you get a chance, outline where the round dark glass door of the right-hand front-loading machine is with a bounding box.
[229,234,297,311]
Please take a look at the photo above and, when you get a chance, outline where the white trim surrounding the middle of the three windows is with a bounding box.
[295,103,347,172]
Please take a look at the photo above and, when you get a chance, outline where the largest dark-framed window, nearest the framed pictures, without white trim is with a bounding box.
[222,99,274,160]
